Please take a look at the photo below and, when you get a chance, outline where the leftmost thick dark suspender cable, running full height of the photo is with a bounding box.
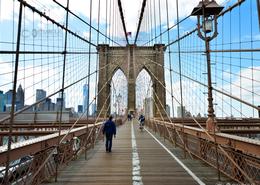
[4,1,23,184]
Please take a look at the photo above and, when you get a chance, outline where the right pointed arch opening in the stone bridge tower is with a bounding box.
[135,68,153,117]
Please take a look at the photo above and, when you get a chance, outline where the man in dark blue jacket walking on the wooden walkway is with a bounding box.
[103,115,116,152]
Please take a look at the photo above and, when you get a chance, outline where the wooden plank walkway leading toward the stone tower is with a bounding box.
[46,121,234,185]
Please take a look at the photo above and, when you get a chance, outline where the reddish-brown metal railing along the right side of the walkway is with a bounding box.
[147,119,260,184]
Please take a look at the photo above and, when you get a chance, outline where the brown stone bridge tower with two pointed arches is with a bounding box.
[97,44,166,117]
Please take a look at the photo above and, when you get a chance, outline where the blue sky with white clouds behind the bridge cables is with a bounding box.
[0,0,260,117]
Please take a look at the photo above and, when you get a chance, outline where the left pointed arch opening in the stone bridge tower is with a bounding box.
[110,68,128,115]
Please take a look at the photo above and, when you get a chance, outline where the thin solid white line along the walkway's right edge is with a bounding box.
[145,128,206,185]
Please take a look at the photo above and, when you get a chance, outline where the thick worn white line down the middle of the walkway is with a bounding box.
[131,120,143,185]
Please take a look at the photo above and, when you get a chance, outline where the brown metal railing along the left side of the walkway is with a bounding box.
[0,122,102,185]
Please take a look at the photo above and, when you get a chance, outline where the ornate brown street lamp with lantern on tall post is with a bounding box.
[191,0,224,132]
